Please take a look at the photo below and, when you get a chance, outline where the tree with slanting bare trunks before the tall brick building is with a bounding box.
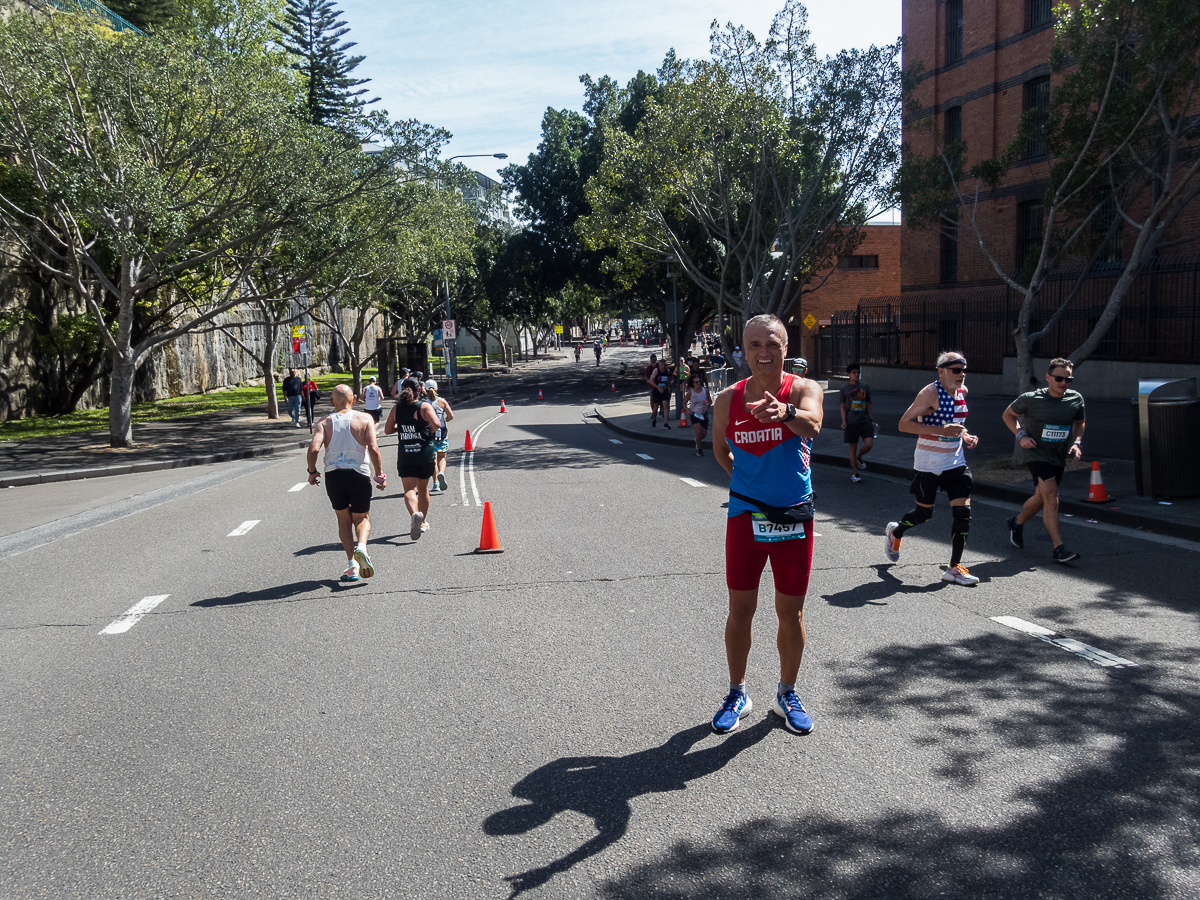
[901,0,1200,385]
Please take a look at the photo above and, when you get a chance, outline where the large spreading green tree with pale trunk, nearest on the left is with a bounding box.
[0,5,446,446]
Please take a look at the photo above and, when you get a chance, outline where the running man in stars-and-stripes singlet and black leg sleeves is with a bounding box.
[883,350,979,584]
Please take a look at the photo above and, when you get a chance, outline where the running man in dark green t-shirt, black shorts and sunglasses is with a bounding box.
[1004,358,1087,563]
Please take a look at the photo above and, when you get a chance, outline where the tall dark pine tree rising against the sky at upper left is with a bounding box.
[276,0,379,127]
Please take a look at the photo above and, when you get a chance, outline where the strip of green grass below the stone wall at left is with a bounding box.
[0,368,377,442]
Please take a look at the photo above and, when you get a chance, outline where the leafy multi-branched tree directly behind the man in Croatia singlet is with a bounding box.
[578,0,902,360]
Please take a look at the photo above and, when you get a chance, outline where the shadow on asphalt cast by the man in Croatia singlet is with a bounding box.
[484,715,774,900]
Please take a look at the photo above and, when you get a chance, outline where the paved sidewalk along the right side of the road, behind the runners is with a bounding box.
[595,396,1200,541]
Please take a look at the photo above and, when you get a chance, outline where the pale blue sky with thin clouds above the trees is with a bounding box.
[337,0,900,184]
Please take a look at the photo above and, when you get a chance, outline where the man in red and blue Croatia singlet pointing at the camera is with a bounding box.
[713,316,823,734]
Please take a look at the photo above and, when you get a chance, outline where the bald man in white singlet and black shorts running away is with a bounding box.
[308,384,388,582]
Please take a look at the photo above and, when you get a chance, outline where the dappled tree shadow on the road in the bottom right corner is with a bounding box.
[601,635,1200,900]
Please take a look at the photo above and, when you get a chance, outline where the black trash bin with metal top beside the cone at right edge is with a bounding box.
[1133,379,1200,497]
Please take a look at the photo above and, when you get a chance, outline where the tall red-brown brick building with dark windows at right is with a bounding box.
[814,0,1200,396]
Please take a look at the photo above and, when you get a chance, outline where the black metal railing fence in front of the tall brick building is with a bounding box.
[814,257,1200,377]
